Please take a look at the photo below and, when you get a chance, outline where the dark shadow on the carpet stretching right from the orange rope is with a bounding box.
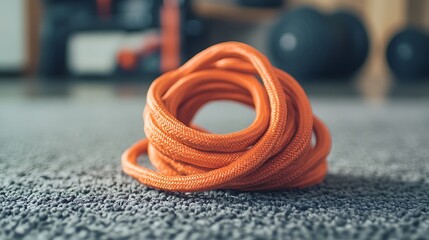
[161,174,429,217]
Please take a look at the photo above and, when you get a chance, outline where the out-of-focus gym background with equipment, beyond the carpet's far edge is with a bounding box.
[0,0,429,98]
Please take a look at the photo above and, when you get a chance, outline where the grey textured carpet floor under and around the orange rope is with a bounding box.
[0,93,429,239]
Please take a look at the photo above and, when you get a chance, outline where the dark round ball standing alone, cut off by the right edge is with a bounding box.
[386,27,429,80]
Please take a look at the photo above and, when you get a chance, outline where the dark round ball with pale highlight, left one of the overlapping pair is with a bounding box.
[269,7,334,78]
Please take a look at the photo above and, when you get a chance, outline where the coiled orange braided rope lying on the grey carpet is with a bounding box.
[122,42,331,192]
